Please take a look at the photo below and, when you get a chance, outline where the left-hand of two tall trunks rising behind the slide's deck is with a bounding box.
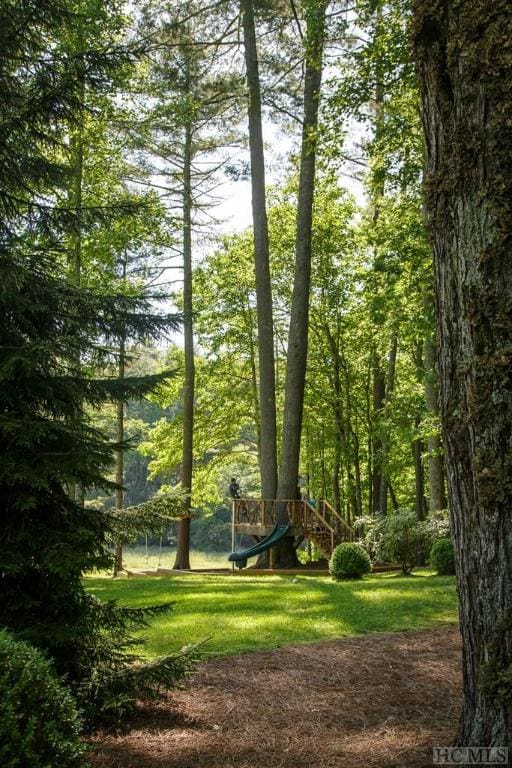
[240,0,277,499]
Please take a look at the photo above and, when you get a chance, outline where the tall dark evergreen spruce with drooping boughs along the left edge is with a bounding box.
[0,0,189,720]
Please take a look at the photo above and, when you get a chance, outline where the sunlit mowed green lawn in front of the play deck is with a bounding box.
[86,571,457,658]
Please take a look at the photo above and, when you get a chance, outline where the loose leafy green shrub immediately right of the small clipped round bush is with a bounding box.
[378,512,427,575]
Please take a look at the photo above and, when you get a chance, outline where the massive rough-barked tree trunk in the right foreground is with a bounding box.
[414,0,512,746]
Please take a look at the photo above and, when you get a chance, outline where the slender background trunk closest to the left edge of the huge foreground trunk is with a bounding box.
[423,306,448,512]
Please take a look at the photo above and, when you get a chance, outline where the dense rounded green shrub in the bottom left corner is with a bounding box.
[0,630,85,768]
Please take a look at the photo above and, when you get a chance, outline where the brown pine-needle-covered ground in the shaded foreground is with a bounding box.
[91,628,460,768]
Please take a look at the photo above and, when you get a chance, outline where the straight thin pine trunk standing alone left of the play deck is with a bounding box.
[174,124,195,570]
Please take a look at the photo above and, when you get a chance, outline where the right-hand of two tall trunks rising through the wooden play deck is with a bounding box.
[275,0,327,566]
